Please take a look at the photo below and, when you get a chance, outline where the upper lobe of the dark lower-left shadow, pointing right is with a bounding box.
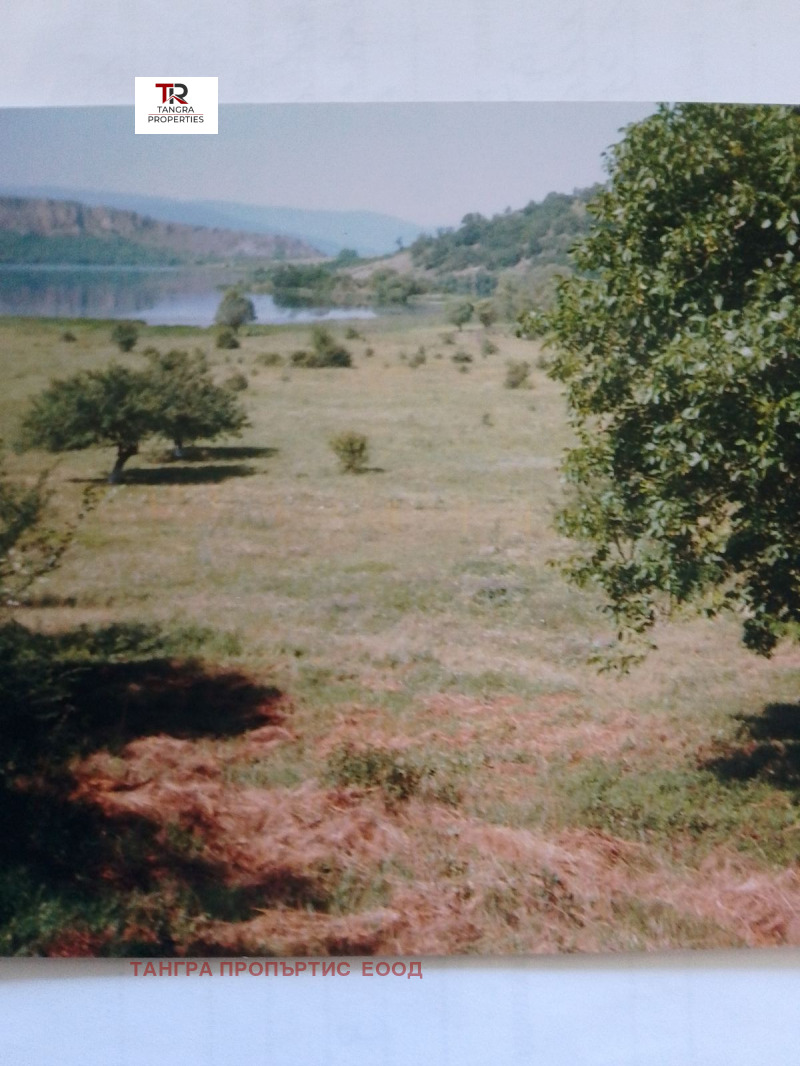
[0,623,283,768]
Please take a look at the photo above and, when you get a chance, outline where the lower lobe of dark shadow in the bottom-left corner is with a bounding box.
[0,776,275,956]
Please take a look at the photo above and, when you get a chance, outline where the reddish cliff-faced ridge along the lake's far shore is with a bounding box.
[0,196,320,263]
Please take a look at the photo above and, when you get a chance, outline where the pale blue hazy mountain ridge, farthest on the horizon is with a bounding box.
[0,185,433,256]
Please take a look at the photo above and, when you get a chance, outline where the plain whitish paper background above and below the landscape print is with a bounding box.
[0,0,800,1066]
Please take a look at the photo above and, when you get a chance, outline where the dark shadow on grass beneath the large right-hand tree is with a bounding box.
[704,704,800,791]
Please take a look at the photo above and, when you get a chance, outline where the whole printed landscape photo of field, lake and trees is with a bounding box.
[0,103,800,957]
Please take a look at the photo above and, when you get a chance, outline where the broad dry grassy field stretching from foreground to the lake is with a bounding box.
[0,316,800,955]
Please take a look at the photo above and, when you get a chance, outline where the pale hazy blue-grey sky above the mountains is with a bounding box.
[0,103,654,227]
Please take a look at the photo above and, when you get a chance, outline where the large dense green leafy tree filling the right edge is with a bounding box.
[535,104,800,655]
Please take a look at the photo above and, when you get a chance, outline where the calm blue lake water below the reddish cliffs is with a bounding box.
[0,267,375,326]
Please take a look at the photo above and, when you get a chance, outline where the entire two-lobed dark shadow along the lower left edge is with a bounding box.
[0,625,297,955]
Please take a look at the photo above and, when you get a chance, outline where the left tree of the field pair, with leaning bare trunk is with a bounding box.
[22,364,158,484]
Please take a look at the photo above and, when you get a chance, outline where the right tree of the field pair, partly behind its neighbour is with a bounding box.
[141,351,247,458]
